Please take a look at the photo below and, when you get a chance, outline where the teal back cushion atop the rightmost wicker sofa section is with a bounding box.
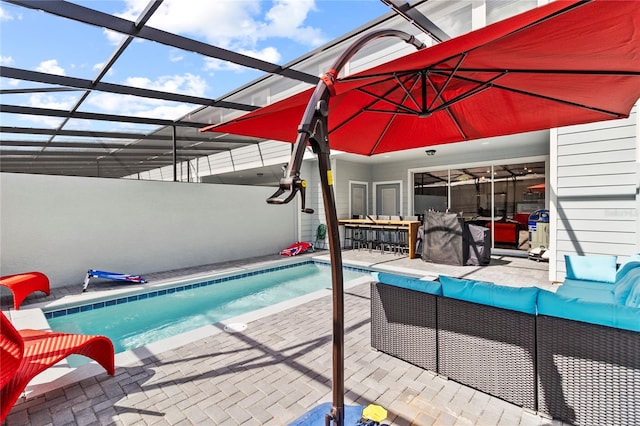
[538,290,640,331]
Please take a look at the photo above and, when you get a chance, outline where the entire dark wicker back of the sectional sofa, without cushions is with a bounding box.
[371,282,640,425]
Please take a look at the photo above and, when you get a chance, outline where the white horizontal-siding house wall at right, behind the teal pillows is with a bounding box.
[549,106,640,281]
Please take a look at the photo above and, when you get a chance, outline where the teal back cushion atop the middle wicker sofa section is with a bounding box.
[440,275,539,314]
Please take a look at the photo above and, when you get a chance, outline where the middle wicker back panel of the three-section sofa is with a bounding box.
[437,297,536,410]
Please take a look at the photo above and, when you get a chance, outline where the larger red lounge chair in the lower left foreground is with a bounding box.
[0,313,115,423]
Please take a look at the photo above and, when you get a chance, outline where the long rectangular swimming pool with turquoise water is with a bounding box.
[45,262,369,353]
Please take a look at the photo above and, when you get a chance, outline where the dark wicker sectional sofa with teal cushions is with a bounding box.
[371,259,640,425]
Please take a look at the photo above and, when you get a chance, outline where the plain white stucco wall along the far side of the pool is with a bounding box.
[0,173,298,287]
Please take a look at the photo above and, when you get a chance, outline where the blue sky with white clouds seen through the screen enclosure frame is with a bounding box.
[0,0,390,127]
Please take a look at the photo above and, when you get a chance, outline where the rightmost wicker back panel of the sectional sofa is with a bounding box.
[537,315,640,425]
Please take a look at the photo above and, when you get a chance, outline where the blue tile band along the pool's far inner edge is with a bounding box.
[44,260,371,319]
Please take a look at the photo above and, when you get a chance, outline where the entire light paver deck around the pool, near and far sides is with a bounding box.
[2,250,562,425]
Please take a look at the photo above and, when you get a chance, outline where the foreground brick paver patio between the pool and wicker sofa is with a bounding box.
[1,251,562,426]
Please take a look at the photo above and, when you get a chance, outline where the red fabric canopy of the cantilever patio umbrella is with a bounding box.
[202,0,640,155]
